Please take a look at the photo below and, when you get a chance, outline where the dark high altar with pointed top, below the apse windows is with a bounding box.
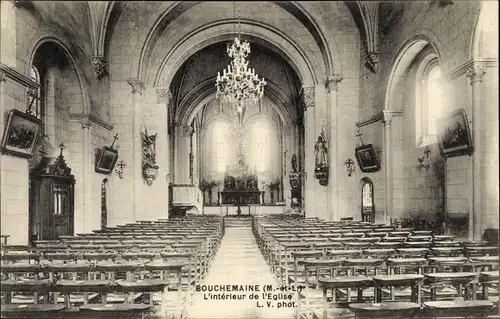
[218,159,264,207]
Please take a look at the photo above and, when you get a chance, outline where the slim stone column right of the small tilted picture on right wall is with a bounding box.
[382,110,394,224]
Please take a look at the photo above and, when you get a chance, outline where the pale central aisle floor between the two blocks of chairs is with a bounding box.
[187,218,295,319]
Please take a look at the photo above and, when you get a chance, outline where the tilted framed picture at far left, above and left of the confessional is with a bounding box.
[1,109,42,158]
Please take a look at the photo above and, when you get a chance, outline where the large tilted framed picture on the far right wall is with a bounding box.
[436,109,473,158]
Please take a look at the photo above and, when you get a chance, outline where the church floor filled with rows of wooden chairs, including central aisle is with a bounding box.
[1,215,499,319]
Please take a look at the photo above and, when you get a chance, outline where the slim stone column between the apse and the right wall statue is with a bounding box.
[302,86,316,217]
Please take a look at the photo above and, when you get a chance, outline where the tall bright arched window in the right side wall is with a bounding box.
[415,54,446,146]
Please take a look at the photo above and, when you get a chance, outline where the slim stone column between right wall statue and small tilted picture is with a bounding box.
[326,76,342,220]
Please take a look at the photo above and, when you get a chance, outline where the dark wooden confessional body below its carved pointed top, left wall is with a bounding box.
[29,175,74,240]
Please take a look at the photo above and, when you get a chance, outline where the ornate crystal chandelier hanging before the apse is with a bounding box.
[215,36,266,113]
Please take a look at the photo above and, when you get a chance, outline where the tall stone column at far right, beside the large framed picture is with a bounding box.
[467,65,486,240]
